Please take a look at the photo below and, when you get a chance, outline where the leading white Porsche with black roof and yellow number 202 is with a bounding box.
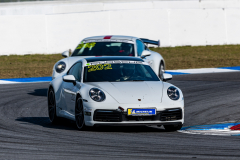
[48,56,184,131]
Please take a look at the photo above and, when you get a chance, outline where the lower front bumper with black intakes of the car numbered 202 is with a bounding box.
[85,108,183,126]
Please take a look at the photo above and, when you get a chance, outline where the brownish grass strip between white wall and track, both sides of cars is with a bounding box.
[0,45,240,79]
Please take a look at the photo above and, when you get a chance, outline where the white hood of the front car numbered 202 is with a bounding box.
[88,81,163,104]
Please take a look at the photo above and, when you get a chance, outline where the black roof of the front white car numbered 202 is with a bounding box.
[85,56,143,62]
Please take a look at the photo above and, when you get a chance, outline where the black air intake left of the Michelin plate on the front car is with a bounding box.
[93,110,122,122]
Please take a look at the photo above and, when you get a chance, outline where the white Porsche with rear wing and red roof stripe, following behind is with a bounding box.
[52,36,165,79]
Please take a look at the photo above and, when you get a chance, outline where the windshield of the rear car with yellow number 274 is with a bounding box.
[72,42,134,56]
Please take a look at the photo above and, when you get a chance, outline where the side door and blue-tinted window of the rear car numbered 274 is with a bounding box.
[136,39,153,68]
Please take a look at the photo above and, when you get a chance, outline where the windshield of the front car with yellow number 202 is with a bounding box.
[83,63,159,82]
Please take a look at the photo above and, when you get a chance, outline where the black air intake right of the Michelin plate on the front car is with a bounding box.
[160,108,182,121]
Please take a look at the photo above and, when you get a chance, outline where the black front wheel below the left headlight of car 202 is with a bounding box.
[75,97,87,130]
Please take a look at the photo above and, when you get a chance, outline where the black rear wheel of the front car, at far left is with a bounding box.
[48,88,60,124]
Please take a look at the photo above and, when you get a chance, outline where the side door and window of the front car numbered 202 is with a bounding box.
[63,62,82,115]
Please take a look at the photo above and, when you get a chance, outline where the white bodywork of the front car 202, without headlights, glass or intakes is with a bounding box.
[50,57,184,126]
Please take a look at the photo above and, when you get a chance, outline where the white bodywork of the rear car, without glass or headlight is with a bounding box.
[52,35,165,79]
